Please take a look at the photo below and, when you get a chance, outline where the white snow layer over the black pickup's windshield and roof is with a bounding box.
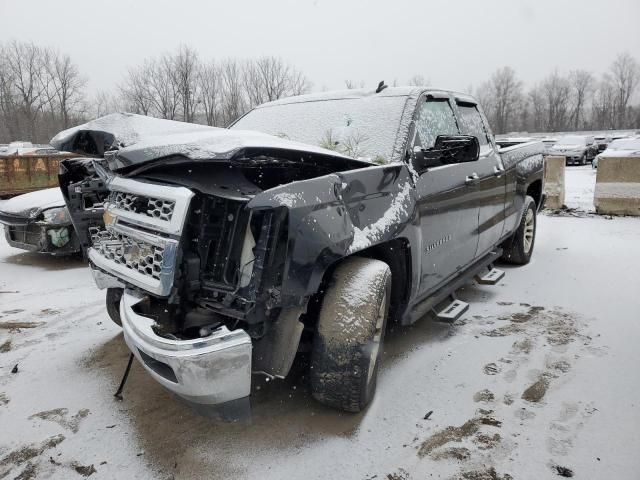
[231,87,476,163]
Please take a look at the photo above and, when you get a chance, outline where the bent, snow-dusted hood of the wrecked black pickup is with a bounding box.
[51,113,372,170]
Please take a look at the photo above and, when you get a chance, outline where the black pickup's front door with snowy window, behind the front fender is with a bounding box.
[413,95,479,295]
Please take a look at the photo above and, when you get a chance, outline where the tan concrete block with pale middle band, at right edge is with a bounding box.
[593,156,640,216]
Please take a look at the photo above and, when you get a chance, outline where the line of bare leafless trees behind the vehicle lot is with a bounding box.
[0,41,640,143]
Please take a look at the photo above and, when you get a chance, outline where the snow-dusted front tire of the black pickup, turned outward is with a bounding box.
[310,257,391,412]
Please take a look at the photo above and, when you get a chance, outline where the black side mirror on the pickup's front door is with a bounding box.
[413,135,480,172]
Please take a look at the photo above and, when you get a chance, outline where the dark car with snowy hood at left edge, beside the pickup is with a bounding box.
[0,188,80,255]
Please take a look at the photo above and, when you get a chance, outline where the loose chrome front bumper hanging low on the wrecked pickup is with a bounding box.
[120,290,251,405]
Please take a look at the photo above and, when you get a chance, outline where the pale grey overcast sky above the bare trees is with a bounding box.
[0,0,640,95]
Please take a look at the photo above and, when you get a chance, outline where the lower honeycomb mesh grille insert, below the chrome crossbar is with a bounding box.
[92,230,164,280]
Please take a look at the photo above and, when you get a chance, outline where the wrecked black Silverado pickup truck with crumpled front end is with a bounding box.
[56,88,544,412]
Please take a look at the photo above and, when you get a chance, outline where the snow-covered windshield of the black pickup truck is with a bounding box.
[231,96,407,163]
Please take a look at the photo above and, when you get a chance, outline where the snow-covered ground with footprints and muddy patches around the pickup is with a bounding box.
[0,167,640,480]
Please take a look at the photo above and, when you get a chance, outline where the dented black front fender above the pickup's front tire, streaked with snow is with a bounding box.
[248,164,416,306]
